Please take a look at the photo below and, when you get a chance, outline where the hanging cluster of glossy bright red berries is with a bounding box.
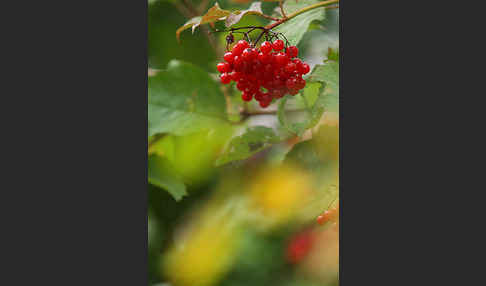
[217,40,310,108]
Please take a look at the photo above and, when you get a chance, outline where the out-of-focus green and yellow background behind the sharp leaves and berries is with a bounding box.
[148,0,339,286]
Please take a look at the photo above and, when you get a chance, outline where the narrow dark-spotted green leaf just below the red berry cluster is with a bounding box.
[216,126,280,166]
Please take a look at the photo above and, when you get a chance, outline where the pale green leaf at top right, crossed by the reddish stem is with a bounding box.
[273,0,326,46]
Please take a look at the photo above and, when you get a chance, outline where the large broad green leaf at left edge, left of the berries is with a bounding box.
[148,60,227,137]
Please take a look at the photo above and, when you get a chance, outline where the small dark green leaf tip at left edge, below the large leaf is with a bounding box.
[148,155,187,201]
